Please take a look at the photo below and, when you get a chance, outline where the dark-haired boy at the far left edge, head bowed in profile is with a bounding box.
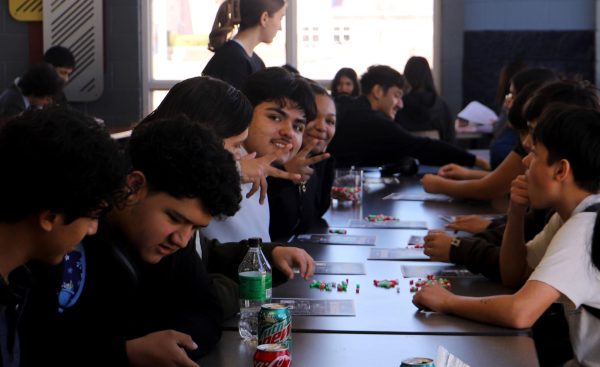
[0,108,125,367]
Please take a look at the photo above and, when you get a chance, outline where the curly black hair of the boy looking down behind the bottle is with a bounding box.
[128,115,242,216]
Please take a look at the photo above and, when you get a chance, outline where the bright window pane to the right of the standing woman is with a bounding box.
[296,0,433,80]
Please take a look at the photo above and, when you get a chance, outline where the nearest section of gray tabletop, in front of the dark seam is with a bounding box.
[198,331,538,367]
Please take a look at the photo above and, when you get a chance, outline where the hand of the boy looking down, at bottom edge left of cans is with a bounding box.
[125,330,198,367]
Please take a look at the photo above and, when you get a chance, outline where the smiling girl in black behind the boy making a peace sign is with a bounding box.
[268,83,336,240]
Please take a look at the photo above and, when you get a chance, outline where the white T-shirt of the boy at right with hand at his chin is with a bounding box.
[527,195,600,366]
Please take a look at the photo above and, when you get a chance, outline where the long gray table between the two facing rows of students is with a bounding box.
[207,168,538,366]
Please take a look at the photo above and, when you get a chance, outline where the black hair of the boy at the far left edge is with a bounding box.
[0,107,127,223]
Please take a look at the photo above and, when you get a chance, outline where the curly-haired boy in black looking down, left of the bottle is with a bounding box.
[22,117,314,366]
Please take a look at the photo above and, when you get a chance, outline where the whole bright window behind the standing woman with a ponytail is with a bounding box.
[141,0,434,113]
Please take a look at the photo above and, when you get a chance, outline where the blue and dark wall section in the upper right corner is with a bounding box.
[462,0,596,110]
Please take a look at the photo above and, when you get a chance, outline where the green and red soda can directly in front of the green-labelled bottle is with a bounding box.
[258,303,292,353]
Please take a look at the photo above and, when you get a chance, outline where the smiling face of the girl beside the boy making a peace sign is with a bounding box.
[304,95,336,154]
